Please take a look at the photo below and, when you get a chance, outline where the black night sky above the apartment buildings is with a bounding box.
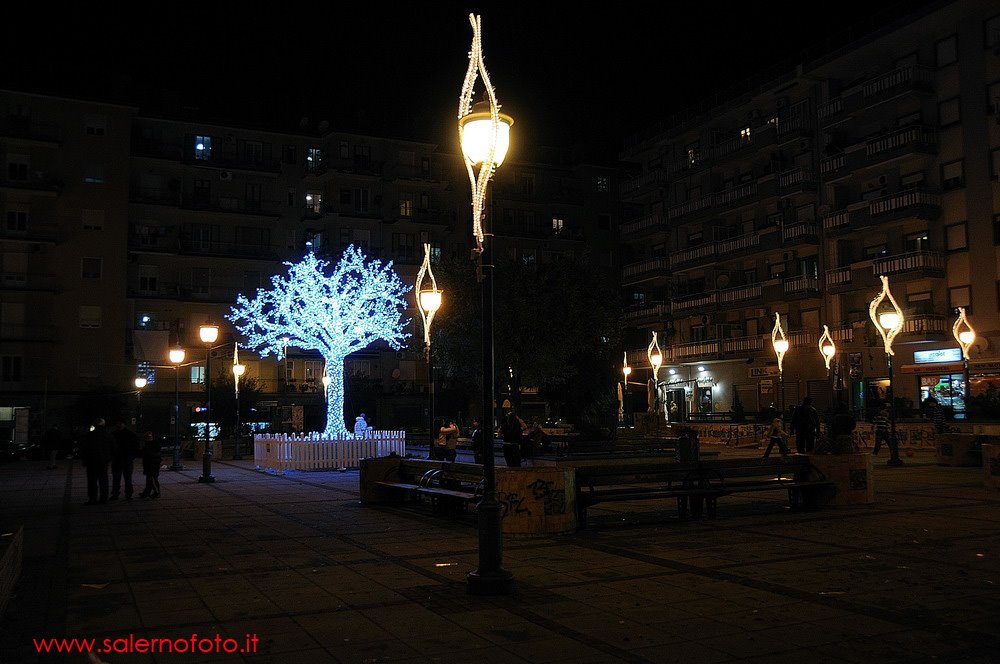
[0,0,929,160]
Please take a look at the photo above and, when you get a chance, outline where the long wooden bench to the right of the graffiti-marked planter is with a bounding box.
[576,456,833,528]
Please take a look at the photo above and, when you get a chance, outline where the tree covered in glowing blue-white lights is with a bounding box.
[226,245,411,437]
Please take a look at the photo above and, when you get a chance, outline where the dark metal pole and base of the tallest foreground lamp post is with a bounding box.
[467,224,514,595]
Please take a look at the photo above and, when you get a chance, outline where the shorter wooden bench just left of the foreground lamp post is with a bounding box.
[375,459,484,511]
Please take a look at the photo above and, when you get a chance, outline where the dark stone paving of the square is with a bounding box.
[0,450,1000,664]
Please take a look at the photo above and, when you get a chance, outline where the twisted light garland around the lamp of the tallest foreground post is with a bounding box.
[458,14,500,253]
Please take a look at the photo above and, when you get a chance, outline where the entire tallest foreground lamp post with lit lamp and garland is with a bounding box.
[458,14,514,595]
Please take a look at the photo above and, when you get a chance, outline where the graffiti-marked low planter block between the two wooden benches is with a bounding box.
[496,466,577,537]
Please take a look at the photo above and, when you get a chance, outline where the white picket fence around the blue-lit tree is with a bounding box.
[253,431,406,473]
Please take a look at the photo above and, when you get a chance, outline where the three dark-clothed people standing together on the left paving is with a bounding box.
[78,418,162,505]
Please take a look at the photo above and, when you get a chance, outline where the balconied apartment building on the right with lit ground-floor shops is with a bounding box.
[620,0,1000,416]
